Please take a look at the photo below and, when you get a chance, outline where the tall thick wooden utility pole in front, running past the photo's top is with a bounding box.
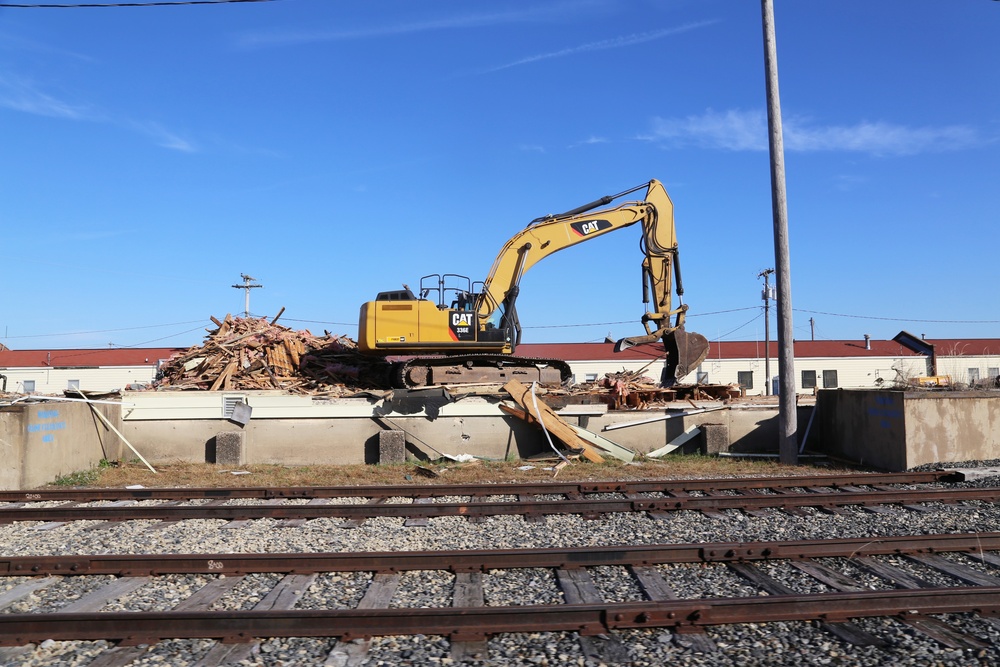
[761,0,799,465]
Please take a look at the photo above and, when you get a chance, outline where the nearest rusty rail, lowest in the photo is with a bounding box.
[0,586,1000,645]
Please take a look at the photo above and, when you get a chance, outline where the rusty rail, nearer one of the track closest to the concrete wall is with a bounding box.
[0,487,1000,523]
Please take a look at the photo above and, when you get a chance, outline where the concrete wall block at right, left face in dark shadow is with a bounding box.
[814,390,1000,471]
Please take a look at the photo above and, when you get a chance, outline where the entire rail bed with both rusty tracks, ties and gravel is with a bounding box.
[0,471,1000,667]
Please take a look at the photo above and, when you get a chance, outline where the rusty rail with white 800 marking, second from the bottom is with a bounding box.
[0,532,1000,577]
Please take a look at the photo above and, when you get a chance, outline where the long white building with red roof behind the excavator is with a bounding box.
[0,334,1000,395]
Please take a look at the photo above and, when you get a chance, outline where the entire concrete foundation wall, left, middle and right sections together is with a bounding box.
[0,390,1000,489]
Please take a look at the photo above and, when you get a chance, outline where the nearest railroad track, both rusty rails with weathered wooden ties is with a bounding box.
[0,533,1000,667]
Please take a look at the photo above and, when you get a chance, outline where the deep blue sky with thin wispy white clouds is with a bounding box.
[0,0,1000,349]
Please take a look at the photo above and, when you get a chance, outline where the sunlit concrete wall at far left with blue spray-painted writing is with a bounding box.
[0,402,122,489]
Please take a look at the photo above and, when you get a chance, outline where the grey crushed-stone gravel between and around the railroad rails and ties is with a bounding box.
[0,462,1000,667]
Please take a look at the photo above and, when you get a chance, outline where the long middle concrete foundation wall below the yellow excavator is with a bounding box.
[122,392,810,465]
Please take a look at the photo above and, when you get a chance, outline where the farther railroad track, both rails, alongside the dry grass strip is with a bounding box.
[0,471,976,526]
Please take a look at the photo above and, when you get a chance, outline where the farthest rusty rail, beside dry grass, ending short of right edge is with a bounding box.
[0,470,965,502]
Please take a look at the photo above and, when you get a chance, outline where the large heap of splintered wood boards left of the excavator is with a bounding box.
[154,313,389,396]
